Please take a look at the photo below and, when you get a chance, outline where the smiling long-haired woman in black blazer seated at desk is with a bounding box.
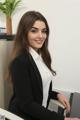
[9,11,78,120]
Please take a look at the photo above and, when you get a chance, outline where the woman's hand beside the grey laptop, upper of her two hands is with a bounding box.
[57,93,70,112]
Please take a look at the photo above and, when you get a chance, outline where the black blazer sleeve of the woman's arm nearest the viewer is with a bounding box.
[11,57,64,120]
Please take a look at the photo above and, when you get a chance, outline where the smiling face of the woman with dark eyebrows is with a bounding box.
[28,20,47,51]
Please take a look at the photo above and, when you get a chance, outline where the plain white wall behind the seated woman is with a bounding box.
[0,0,80,92]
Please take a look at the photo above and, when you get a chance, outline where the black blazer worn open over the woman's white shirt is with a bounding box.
[9,50,64,120]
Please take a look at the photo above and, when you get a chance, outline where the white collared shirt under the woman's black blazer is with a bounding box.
[29,47,53,107]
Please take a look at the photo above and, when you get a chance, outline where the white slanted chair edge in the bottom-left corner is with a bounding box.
[0,108,24,120]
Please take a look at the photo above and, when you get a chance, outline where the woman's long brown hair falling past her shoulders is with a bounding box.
[8,11,56,78]
